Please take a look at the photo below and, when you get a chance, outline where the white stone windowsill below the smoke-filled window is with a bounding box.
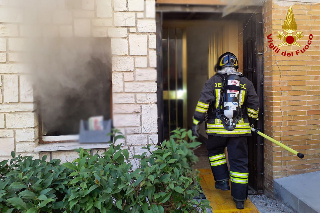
[34,142,110,152]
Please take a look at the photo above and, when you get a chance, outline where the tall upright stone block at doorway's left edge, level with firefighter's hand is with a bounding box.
[141,104,158,133]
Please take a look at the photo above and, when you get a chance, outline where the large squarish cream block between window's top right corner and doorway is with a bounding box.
[129,35,148,55]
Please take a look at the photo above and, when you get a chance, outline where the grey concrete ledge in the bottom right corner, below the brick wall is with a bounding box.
[273,172,320,213]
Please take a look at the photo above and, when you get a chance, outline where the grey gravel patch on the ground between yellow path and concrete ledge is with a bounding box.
[249,195,295,213]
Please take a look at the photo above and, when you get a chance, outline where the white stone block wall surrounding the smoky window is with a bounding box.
[0,0,158,160]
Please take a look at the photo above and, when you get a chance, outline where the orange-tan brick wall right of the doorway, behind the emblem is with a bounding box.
[263,1,320,196]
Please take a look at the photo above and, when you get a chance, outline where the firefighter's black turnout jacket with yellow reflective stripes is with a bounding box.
[193,74,259,137]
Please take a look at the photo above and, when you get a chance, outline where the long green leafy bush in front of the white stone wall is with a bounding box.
[0,130,209,213]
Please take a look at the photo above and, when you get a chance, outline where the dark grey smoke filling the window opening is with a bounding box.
[31,38,111,135]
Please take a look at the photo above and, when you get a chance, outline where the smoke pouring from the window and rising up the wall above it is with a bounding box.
[16,0,111,135]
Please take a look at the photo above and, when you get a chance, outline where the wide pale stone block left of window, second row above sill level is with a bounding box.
[6,112,36,129]
